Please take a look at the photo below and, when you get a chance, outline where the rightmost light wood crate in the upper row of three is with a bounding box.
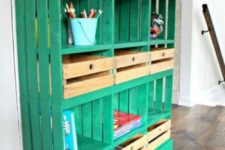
[150,48,174,74]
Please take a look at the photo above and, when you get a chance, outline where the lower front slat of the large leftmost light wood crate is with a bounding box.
[64,72,113,98]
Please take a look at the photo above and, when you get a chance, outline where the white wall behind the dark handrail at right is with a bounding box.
[179,0,225,106]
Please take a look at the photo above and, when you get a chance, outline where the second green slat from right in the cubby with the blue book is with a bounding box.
[92,99,103,141]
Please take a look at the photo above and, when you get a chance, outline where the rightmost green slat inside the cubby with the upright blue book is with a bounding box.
[102,95,114,144]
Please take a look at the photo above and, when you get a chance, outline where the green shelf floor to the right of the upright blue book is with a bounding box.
[77,136,111,150]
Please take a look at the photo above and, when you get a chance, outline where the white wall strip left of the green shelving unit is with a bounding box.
[0,0,21,150]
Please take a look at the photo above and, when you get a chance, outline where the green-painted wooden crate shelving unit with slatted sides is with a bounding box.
[16,0,175,150]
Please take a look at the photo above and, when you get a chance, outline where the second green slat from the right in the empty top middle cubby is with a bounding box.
[129,0,140,42]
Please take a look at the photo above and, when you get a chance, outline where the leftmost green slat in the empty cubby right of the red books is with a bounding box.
[148,81,155,111]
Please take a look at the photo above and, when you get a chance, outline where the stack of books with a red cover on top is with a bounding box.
[114,111,141,139]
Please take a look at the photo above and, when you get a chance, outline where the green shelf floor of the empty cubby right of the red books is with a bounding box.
[148,111,171,126]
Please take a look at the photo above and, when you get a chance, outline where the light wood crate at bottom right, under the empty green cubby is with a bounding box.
[147,120,171,142]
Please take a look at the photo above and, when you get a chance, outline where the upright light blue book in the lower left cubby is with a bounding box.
[63,111,78,150]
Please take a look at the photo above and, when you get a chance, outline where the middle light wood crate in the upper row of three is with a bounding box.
[115,50,149,84]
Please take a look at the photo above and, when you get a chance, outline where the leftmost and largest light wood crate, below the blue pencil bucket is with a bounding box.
[63,55,113,98]
